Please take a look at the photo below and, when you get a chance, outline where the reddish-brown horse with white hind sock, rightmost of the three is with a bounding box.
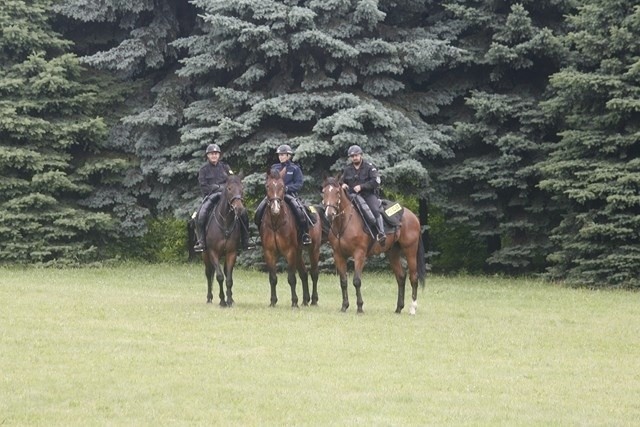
[322,177,426,314]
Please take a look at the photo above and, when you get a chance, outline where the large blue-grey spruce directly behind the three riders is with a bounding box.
[168,0,459,217]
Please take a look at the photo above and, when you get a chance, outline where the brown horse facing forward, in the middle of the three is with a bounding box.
[260,170,322,307]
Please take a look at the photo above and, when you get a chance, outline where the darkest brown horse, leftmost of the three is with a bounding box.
[202,175,245,307]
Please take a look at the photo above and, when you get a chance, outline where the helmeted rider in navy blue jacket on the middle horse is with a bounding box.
[255,144,311,245]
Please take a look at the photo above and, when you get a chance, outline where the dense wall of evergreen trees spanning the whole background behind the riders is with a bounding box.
[0,0,640,287]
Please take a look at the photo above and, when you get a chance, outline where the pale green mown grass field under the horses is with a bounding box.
[0,264,640,426]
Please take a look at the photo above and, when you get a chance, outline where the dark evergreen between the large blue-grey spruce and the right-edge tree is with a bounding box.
[434,1,570,273]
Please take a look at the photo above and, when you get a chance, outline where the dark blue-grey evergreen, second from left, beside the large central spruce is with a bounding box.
[56,0,197,226]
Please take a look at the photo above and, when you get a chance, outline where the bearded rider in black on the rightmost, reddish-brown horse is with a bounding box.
[342,145,386,246]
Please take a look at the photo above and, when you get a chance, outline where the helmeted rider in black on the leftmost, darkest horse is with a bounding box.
[193,144,249,252]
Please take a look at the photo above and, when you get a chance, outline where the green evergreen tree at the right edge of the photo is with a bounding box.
[541,0,640,288]
